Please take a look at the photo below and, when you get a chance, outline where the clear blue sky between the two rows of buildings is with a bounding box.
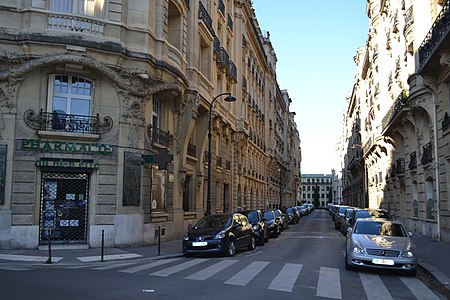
[253,0,369,174]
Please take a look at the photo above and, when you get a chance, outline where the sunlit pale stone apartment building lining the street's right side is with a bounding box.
[343,0,450,242]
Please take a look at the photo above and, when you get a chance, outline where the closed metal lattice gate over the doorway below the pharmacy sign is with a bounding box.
[39,173,89,244]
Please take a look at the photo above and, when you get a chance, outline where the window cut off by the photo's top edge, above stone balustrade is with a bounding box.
[50,0,105,18]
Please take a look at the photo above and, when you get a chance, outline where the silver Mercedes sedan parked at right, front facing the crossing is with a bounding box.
[345,219,417,276]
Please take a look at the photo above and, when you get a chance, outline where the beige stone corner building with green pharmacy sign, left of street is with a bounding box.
[0,0,300,249]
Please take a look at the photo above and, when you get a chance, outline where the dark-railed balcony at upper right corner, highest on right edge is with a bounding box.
[418,0,450,74]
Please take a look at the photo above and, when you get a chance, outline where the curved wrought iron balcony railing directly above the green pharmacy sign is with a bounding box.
[24,109,113,134]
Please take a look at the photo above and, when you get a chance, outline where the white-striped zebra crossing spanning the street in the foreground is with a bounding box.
[0,257,441,300]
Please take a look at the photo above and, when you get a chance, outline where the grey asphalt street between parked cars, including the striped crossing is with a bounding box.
[0,210,446,300]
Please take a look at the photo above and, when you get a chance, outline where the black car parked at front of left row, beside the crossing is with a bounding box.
[183,213,256,256]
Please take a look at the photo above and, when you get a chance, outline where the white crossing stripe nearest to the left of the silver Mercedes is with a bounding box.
[316,267,342,299]
